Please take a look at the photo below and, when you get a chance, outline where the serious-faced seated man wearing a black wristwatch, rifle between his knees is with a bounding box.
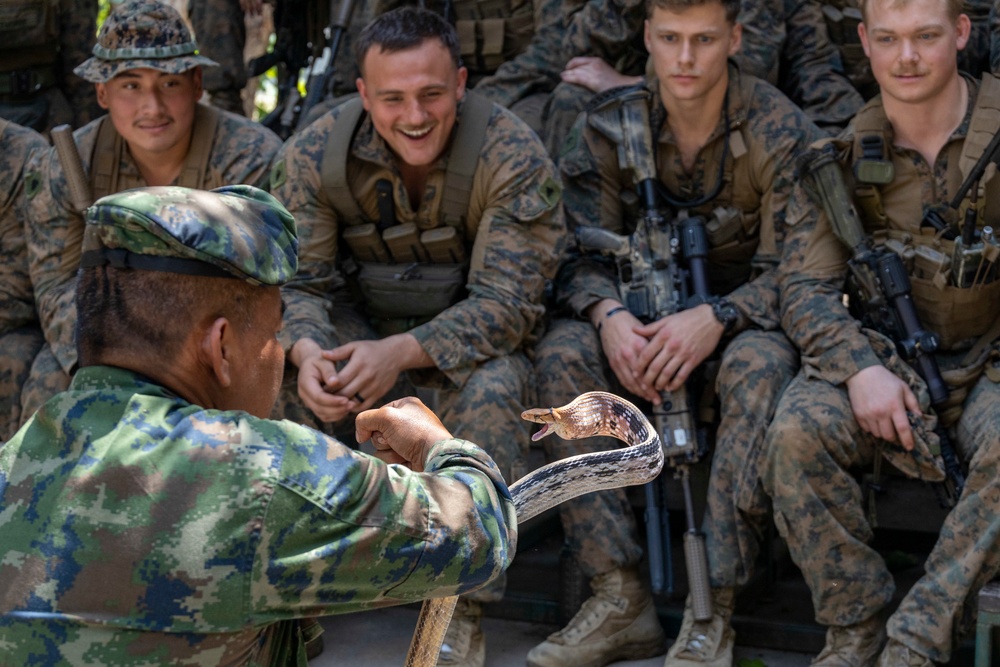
[529,0,821,667]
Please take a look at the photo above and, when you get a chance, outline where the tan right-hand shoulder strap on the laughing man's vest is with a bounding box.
[441,92,493,230]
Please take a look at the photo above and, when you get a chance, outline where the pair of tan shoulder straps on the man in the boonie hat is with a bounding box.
[90,104,224,201]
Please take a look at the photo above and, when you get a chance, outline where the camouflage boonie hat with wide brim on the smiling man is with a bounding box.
[73,0,219,83]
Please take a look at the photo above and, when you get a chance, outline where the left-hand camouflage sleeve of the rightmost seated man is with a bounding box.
[779,179,880,384]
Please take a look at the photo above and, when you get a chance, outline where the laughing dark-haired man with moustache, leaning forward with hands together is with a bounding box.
[271,7,565,665]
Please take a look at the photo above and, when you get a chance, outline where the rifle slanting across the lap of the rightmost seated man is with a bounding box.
[799,143,965,507]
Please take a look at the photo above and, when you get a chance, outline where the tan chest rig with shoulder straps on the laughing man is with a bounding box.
[321,93,492,324]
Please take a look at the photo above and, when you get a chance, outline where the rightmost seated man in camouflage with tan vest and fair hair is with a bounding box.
[761,0,1000,667]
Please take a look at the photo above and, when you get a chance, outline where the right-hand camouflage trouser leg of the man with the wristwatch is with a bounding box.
[703,330,799,588]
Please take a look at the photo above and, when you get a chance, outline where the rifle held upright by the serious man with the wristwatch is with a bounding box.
[577,88,712,620]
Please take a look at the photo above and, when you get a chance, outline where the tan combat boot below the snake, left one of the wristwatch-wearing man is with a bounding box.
[527,568,666,667]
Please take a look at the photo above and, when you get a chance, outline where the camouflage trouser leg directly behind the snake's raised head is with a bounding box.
[535,320,642,578]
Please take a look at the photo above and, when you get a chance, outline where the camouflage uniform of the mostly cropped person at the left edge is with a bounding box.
[0,119,48,442]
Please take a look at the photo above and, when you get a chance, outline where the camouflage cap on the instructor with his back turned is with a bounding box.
[80,185,299,285]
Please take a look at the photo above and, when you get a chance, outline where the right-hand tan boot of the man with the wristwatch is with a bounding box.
[663,588,736,667]
